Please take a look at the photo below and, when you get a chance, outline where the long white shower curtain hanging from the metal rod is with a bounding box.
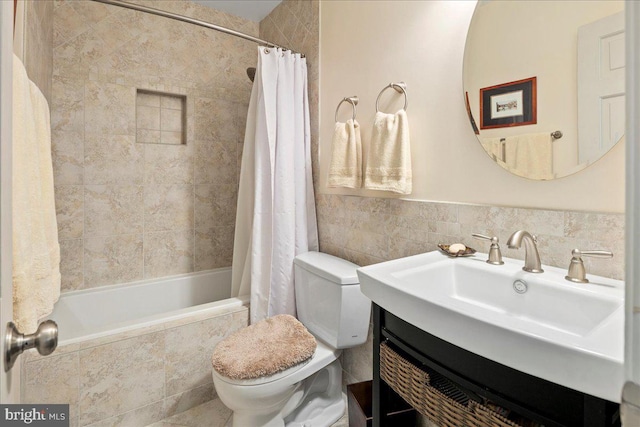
[232,47,318,323]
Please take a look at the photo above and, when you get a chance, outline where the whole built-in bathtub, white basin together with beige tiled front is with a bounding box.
[26,268,249,426]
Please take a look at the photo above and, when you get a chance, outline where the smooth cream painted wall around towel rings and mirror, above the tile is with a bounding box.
[319,1,624,213]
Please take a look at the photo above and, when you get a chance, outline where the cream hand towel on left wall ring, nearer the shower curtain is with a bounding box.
[329,119,362,188]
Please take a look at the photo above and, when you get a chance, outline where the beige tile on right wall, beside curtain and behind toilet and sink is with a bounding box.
[260,0,624,383]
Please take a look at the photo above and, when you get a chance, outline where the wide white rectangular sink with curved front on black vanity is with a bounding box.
[358,252,624,402]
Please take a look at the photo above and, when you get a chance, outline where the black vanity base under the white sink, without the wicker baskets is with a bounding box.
[373,304,620,427]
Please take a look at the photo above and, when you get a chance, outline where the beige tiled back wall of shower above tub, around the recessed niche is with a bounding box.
[47,0,258,291]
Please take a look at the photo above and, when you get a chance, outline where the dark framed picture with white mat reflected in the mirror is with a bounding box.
[480,77,537,129]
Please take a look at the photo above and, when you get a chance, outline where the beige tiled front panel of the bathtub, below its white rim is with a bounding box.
[21,306,249,427]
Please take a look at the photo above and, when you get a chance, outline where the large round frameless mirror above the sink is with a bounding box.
[463,0,625,180]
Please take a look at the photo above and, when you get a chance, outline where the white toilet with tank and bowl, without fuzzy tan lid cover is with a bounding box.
[213,252,371,427]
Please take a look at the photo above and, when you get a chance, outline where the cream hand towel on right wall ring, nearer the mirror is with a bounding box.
[364,110,411,194]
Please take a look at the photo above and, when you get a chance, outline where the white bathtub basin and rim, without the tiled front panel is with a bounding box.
[48,268,248,345]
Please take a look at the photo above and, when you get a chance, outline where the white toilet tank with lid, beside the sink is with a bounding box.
[294,252,371,349]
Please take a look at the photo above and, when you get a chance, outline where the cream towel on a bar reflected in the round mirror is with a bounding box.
[504,132,553,180]
